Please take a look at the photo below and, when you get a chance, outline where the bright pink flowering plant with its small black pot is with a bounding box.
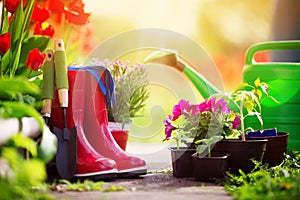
[164,98,239,177]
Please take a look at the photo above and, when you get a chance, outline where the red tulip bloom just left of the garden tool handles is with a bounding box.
[25,48,46,71]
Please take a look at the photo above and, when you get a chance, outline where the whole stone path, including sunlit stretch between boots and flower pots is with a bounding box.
[52,144,232,200]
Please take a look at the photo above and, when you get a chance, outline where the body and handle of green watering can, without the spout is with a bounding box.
[243,40,300,150]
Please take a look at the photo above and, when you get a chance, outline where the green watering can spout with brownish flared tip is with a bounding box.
[144,49,222,98]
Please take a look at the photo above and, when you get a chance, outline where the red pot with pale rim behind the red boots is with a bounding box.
[108,122,130,151]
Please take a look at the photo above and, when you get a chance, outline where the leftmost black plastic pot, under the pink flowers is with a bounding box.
[169,147,196,178]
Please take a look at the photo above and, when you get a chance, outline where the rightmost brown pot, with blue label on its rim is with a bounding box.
[251,132,289,167]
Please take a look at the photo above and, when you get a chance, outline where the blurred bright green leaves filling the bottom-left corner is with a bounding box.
[0,138,52,199]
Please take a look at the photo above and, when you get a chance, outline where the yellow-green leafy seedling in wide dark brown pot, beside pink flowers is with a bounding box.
[214,78,278,173]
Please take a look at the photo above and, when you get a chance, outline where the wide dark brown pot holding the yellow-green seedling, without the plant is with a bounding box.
[213,139,268,174]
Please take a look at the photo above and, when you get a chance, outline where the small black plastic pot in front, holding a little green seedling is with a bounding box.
[192,152,230,182]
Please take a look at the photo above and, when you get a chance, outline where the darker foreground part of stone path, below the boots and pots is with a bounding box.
[52,174,232,200]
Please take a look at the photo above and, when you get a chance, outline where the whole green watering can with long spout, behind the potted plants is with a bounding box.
[145,41,300,150]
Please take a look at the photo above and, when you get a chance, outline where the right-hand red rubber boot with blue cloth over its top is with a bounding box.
[84,67,147,177]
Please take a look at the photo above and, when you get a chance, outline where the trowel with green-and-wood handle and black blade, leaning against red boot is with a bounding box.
[53,39,77,179]
